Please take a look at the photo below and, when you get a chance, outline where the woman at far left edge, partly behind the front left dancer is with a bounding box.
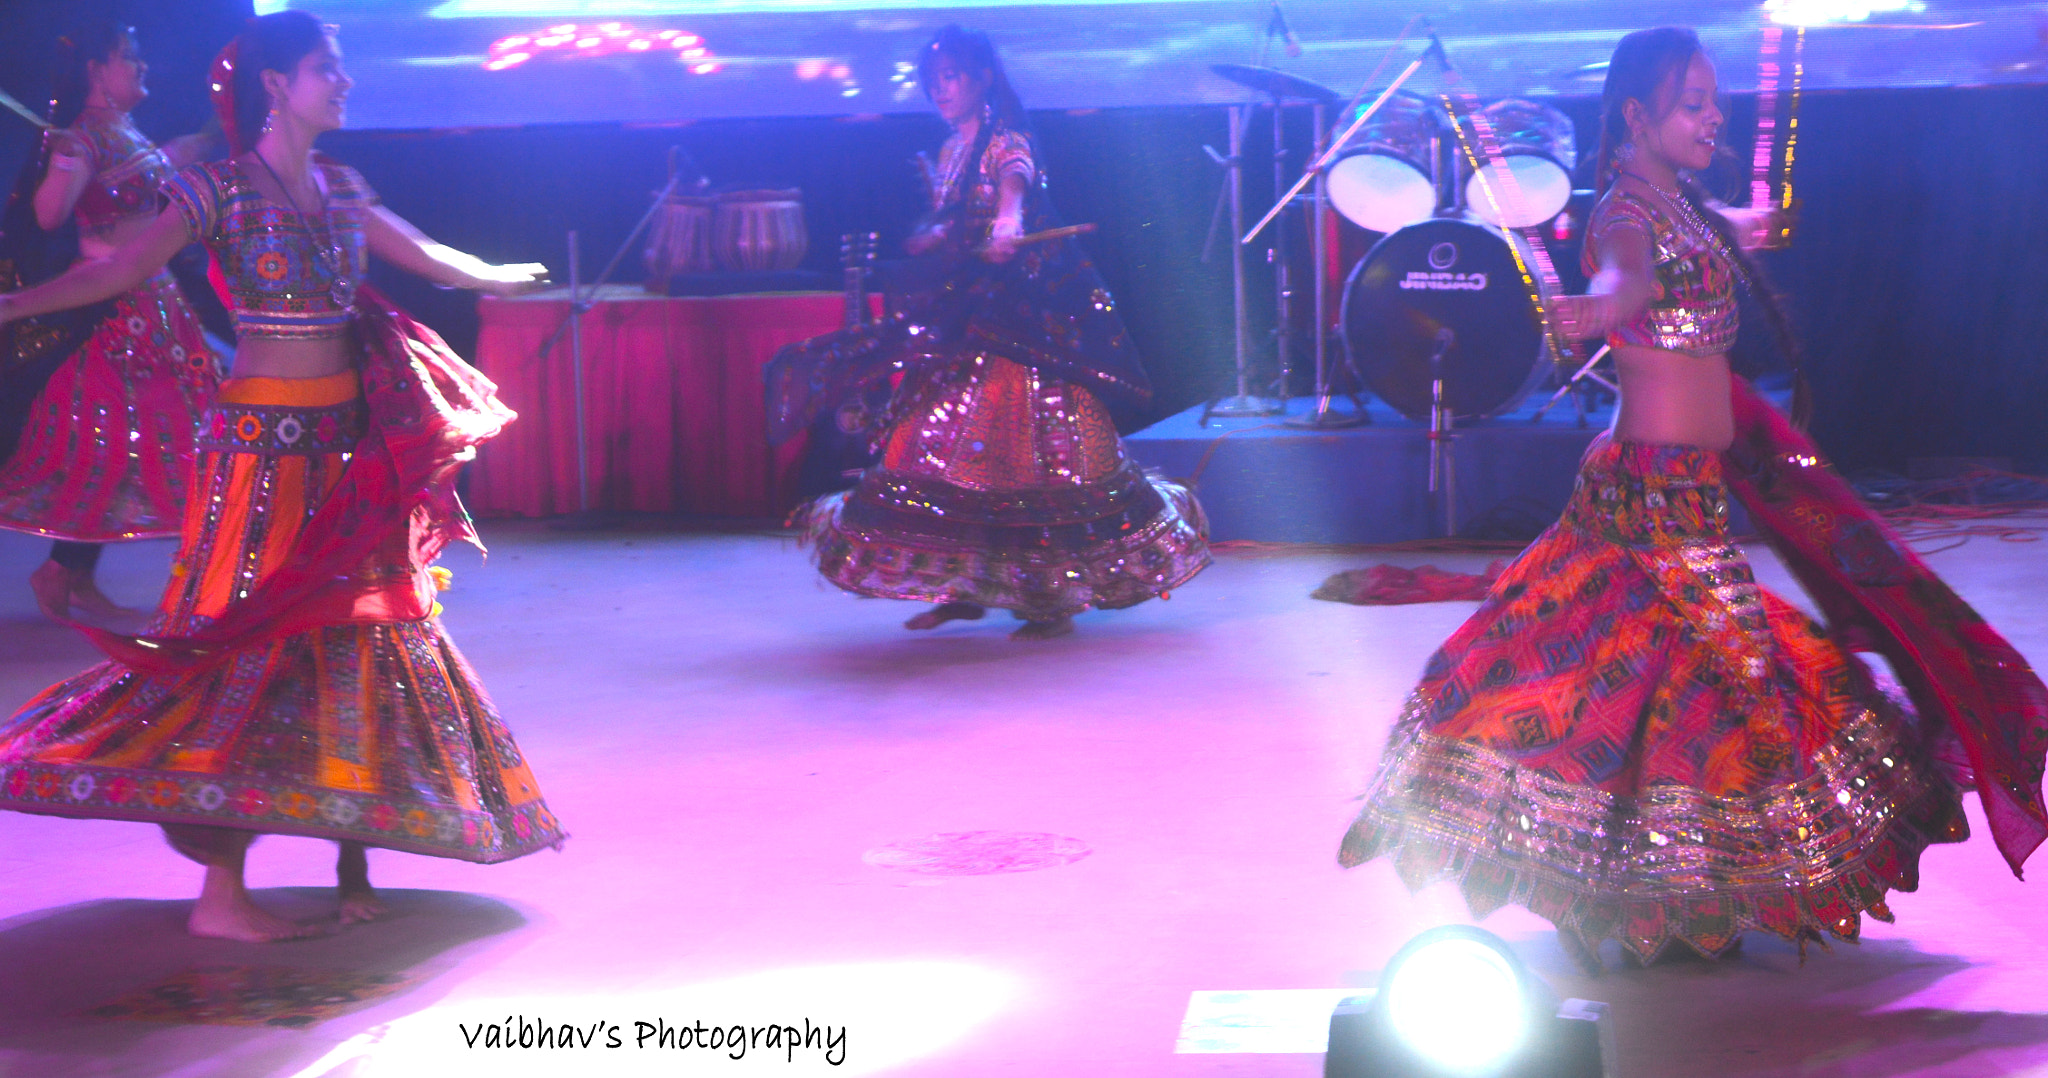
[0,23,217,621]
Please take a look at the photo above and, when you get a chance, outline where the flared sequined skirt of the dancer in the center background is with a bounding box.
[799,355,1208,621]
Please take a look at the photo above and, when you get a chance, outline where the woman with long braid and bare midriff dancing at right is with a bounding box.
[1341,29,2048,969]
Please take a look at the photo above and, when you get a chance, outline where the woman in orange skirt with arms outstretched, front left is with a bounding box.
[0,10,561,941]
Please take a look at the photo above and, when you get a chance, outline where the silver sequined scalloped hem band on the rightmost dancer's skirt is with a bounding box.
[1337,695,1968,959]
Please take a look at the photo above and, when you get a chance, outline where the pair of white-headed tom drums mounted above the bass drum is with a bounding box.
[1329,92,1579,232]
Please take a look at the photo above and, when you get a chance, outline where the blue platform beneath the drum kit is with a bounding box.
[1124,391,1614,543]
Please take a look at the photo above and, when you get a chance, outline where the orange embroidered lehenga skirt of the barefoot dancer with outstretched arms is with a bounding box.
[0,373,561,863]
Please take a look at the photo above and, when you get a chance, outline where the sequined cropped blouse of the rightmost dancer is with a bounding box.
[1585,189,1741,357]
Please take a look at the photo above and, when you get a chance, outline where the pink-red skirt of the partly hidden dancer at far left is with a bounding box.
[0,273,217,543]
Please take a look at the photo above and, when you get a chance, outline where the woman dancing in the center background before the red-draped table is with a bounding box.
[778,27,1208,639]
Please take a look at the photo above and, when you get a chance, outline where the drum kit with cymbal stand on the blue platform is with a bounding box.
[1208,45,1577,426]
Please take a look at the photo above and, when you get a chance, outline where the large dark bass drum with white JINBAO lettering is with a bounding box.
[1341,219,1546,422]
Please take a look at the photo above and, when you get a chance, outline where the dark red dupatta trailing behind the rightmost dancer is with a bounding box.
[1724,379,2048,875]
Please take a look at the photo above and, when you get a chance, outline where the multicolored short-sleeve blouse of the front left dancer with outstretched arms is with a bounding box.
[164,156,379,340]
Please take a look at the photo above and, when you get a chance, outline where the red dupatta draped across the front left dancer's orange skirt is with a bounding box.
[78,285,514,674]
